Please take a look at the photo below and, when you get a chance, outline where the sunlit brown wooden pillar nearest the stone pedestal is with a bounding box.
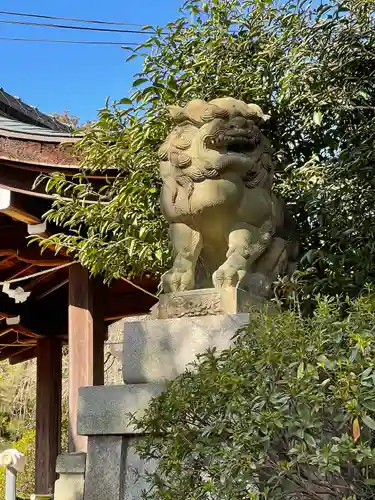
[69,264,104,452]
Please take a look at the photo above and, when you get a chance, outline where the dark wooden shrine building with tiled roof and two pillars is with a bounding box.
[0,89,156,494]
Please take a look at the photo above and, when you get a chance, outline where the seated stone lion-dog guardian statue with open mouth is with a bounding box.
[159,97,298,296]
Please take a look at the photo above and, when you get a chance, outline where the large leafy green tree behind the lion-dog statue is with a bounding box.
[36,0,375,294]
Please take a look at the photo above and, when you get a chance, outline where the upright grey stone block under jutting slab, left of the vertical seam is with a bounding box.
[84,436,126,500]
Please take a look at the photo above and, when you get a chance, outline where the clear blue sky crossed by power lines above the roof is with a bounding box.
[0,0,182,120]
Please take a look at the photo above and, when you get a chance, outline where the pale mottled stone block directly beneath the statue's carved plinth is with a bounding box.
[123,314,249,384]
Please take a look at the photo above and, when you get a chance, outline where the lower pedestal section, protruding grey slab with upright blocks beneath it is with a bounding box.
[78,384,165,500]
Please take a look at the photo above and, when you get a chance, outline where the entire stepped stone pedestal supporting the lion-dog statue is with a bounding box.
[76,289,263,500]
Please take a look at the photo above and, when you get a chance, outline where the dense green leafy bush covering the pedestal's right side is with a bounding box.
[135,291,375,500]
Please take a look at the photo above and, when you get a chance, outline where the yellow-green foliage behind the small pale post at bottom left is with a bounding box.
[0,429,35,498]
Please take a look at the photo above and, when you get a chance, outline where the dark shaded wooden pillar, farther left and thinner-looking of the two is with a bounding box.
[35,337,62,495]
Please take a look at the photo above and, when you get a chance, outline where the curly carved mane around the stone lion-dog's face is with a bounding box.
[159,98,272,197]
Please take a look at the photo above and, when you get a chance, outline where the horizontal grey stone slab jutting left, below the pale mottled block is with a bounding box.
[78,384,165,436]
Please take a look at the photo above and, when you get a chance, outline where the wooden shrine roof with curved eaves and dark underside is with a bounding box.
[0,114,156,364]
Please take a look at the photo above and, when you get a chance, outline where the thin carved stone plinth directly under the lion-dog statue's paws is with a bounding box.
[152,288,266,319]
